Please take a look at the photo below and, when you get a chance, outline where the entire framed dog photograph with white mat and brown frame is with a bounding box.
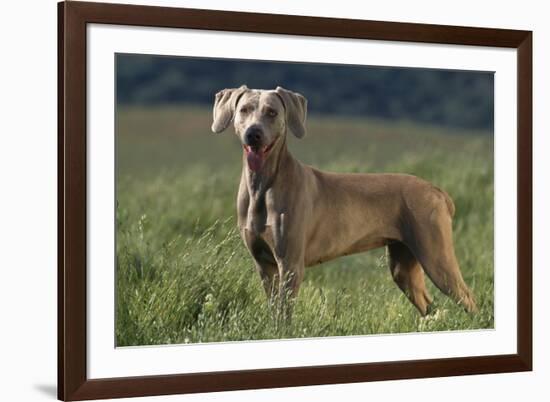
[58,1,532,400]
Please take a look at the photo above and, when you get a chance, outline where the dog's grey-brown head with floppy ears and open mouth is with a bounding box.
[212,85,307,171]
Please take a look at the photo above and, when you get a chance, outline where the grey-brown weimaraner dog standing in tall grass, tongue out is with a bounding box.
[212,85,476,315]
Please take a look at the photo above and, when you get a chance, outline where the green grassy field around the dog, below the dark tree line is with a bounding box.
[116,106,494,346]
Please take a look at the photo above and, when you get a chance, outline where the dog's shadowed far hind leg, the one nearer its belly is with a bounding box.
[388,242,432,316]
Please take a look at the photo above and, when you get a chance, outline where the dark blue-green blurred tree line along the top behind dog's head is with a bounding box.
[116,54,494,129]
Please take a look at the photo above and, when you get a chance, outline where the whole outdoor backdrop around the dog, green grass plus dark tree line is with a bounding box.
[116,54,494,346]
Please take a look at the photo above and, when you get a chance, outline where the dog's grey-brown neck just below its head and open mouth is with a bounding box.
[243,135,294,200]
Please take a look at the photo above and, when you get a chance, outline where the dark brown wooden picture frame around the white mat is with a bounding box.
[58,1,532,400]
